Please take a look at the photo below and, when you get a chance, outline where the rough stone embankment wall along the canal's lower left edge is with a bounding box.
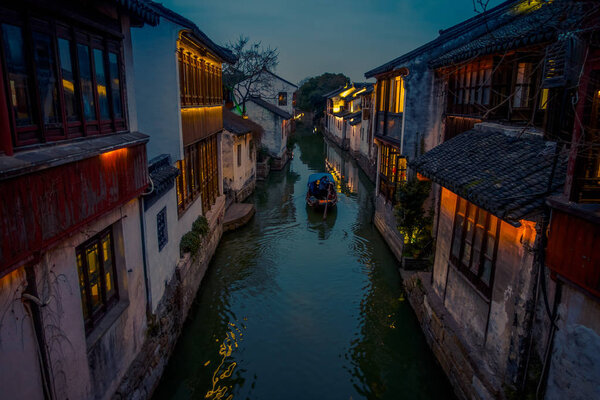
[113,196,225,399]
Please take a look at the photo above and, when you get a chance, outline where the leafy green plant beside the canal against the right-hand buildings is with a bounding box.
[395,179,433,270]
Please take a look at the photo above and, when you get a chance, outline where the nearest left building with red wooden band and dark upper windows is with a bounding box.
[0,0,158,399]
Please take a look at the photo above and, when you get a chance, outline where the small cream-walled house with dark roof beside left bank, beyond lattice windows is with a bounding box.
[222,110,263,202]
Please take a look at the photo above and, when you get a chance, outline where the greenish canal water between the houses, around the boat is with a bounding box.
[154,126,453,400]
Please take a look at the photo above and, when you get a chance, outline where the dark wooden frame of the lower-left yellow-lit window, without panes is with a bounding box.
[75,226,119,335]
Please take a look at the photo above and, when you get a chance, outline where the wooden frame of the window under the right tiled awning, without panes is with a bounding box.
[449,196,502,300]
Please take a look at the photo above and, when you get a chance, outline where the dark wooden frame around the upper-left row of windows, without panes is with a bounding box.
[0,9,127,150]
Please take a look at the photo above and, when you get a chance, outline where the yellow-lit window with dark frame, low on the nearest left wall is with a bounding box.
[76,228,119,333]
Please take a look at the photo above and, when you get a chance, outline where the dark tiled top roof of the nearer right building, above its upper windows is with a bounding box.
[430,0,591,68]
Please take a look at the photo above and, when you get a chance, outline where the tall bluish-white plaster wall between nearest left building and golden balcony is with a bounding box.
[130,18,183,160]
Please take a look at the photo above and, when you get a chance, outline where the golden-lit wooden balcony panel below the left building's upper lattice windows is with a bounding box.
[181,105,223,146]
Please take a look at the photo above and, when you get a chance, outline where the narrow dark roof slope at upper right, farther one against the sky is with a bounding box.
[365,0,522,78]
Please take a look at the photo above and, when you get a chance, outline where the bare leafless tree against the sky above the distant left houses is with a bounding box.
[223,35,279,111]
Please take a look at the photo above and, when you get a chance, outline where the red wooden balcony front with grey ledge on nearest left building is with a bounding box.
[0,133,148,277]
